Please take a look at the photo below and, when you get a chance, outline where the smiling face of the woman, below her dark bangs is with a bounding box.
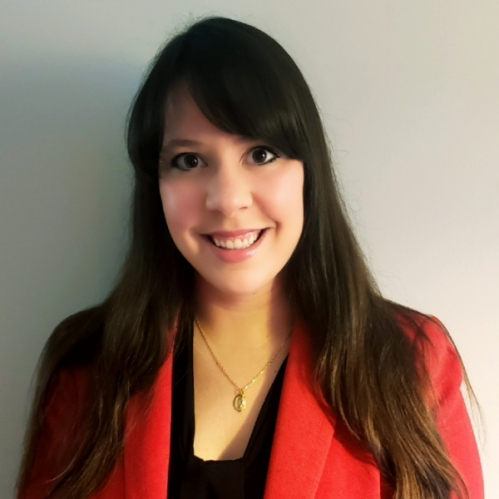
[159,89,304,295]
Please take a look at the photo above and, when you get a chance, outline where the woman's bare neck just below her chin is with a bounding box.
[196,281,293,349]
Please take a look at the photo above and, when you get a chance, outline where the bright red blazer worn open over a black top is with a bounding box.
[24,320,483,499]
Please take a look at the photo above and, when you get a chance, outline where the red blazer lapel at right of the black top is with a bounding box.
[265,323,334,499]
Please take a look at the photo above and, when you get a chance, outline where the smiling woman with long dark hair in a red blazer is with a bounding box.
[19,18,483,499]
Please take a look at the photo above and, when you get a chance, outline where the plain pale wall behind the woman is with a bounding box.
[0,0,499,499]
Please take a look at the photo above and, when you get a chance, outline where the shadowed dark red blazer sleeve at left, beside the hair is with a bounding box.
[19,370,84,499]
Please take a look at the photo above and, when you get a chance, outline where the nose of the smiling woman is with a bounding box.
[206,164,253,218]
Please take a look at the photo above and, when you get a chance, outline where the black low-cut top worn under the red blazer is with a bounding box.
[168,331,286,499]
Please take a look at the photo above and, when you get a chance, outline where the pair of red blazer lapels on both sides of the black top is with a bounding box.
[124,322,334,499]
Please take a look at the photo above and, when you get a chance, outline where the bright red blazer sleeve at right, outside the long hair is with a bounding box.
[425,318,484,499]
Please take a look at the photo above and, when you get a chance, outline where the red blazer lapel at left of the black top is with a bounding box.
[124,355,173,499]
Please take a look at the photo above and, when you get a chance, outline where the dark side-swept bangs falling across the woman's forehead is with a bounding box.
[172,22,304,160]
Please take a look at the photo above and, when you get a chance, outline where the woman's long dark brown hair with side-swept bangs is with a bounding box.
[18,18,466,499]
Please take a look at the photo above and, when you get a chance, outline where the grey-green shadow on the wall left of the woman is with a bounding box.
[0,59,140,497]
